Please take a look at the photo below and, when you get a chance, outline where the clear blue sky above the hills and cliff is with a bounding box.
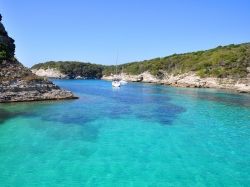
[0,0,250,67]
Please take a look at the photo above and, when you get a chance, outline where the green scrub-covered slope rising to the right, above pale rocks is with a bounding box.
[103,43,250,79]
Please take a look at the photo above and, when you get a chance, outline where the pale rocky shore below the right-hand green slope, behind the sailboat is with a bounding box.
[102,72,250,93]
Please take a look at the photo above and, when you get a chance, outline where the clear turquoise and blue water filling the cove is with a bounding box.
[0,80,250,187]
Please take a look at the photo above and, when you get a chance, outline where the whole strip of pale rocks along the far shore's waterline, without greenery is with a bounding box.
[32,68,250,94]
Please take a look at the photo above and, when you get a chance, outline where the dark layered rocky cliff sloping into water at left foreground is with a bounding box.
[0,15,78,102]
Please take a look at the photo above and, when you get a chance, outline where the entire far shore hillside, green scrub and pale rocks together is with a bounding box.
[32,40,250,93]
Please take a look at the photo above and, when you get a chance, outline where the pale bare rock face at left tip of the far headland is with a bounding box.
[31,68,70,79]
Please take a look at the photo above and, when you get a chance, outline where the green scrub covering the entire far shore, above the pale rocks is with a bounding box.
[32,43,250,78]
